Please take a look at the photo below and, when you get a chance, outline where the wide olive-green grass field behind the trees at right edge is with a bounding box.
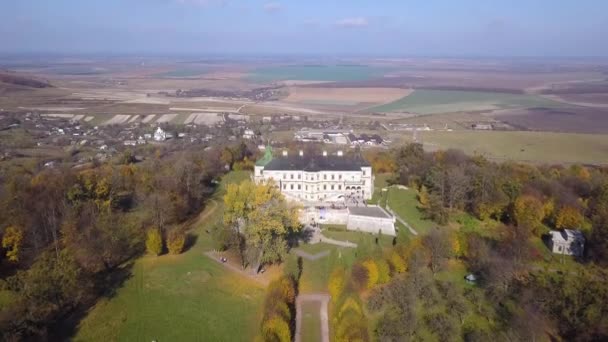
[426,131,608,164]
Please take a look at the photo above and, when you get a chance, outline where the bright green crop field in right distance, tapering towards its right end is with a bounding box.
[366,90,563,114]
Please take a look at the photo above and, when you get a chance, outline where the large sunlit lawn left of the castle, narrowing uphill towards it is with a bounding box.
[74,172,264,341]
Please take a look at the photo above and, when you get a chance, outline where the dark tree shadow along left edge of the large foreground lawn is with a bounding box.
[46,261,134,341]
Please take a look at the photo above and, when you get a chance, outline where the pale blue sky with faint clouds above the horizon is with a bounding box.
[0,0,608,56]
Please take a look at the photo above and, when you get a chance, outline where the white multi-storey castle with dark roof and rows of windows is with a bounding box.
[254,148,374,202]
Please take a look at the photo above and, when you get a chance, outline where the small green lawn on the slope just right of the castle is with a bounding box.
[387,187,437,234]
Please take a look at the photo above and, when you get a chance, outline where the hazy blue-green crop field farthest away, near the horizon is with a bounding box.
[249,65,386,82]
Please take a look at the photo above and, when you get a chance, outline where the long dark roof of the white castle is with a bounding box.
[264,155,370,172]
